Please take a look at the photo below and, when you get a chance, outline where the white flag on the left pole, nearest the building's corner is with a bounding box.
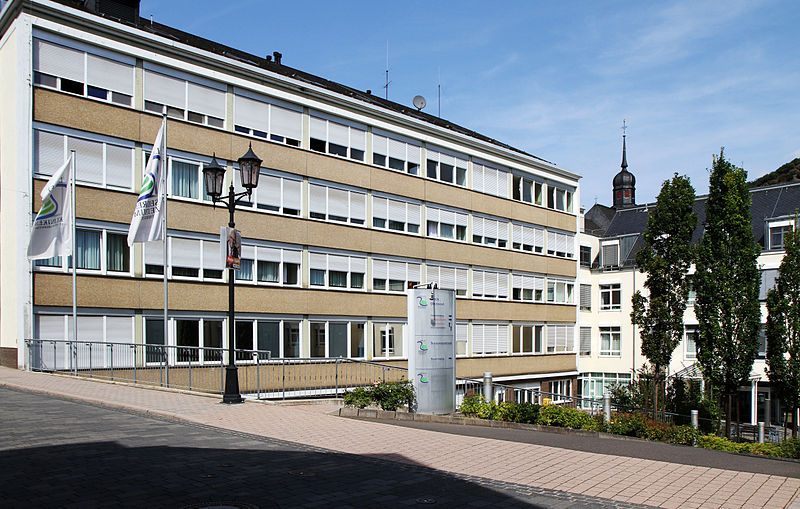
[28,158,72,260]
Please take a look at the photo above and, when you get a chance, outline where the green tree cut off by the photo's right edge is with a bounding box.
[767,219,800,436]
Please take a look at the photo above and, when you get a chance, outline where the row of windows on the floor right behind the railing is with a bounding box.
[34,313,574,360]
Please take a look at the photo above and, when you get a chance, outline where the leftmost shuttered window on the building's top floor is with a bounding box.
[33,37,135,106]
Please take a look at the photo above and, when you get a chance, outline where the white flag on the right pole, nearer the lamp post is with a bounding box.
[128,119,167,246]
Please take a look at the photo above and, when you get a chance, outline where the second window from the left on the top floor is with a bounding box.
[144,66,227,128]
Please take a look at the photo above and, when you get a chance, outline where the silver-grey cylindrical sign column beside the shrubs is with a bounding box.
[406,288,456,414]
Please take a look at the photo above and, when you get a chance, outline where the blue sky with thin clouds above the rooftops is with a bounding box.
[140,0,800,207]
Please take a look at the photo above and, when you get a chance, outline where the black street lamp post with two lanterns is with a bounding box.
[203,143,261,403]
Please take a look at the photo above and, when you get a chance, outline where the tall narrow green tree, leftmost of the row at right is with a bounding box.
[631,173,697,411]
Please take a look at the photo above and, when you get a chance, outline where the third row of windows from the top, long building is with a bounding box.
[35,228,575,304]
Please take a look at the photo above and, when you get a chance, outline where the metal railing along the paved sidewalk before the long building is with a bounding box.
[25,339,408,399]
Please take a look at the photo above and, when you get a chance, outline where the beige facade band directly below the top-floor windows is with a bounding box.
[34,88,576,232]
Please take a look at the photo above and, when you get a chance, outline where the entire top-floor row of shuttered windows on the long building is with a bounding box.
[33,33,573,212]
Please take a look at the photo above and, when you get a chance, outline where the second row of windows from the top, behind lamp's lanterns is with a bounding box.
[34,124,575,258]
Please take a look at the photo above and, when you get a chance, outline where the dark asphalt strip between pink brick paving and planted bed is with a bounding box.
[360,414,800,478]
